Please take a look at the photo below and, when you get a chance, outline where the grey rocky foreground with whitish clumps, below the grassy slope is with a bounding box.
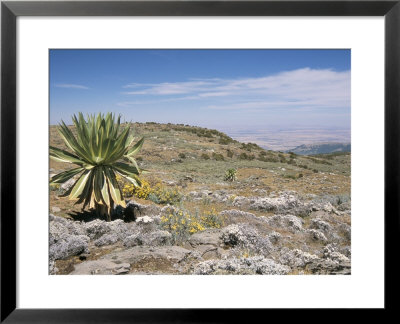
[49,190,351,275]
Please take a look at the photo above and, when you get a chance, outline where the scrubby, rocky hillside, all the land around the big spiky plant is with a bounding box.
[49,122,351,274]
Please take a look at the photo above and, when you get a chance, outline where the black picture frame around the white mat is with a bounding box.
[0,0,400,323]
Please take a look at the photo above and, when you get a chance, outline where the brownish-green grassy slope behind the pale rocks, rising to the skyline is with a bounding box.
[50,123,351,219]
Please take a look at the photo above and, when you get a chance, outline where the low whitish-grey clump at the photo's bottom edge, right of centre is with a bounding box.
[193,256,290,275]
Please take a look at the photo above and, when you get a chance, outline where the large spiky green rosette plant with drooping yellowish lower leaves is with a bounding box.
[50,113,144,221]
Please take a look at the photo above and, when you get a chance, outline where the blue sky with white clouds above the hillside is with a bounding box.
[49,49,351,139]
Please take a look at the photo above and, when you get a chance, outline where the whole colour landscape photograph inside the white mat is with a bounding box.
[49,48,355,275]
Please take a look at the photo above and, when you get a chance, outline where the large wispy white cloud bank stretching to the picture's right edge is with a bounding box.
[124,68,351,109]
